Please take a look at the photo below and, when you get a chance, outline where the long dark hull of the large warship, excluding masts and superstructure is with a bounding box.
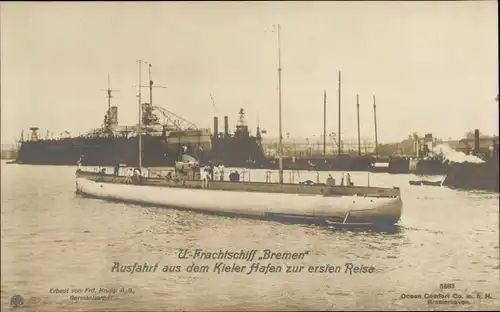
[16,135,266,168]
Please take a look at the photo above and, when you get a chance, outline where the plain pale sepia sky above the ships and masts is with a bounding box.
[0,1,499,143]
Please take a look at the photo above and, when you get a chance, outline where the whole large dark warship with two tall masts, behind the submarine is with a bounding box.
[15,65,266,167]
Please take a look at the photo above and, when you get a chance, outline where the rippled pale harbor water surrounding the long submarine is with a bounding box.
[1,161,500,311]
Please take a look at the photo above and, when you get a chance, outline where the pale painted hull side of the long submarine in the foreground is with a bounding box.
[76,177,402,225]
